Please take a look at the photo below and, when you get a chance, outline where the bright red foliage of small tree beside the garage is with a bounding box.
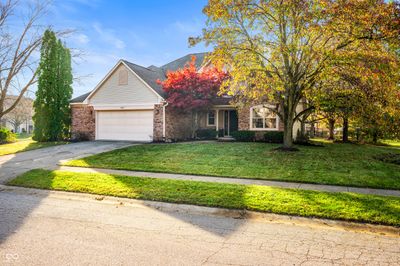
[158,56,228,111]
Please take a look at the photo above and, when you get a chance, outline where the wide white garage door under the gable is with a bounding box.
[96,110,153,141]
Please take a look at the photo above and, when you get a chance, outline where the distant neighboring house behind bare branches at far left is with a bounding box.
[0,95,33,134]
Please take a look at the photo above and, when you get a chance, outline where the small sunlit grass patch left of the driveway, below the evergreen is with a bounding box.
[0,138,67,156]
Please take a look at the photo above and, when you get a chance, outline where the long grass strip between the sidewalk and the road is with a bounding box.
[8,169,400,226]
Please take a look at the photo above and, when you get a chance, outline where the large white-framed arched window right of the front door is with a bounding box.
[250,105,279,130]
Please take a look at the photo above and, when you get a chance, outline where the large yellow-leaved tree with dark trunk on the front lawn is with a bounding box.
[189,0,400,149]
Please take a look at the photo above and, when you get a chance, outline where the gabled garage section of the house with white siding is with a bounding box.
[71,60,170,142]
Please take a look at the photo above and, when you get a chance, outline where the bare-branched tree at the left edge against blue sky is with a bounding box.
[0,0,47,119]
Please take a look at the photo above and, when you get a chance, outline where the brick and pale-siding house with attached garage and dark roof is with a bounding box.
[71,53,298,141]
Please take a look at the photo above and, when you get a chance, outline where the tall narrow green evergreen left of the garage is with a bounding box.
[33,30,72,141]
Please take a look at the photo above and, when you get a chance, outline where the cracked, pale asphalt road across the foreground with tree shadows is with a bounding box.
[0,187,400,265]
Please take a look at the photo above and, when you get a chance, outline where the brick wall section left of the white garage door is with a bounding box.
[71,105,95,140]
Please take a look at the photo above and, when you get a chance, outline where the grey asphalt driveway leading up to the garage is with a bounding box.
[0,141,134,184]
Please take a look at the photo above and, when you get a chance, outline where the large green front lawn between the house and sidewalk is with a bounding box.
[66,142,400,189]
